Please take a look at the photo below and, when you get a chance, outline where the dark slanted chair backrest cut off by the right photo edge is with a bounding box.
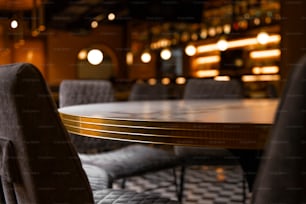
[253,56,306,204]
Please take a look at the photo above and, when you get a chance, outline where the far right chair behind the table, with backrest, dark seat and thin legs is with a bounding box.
[174,78,245,200]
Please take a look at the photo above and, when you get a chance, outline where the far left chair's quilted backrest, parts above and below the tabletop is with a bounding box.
[59,80,128,153]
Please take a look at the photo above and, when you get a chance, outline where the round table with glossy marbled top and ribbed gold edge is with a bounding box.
[59,99,278,149]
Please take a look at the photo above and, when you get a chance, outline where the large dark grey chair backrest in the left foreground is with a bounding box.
[0,63,93,204]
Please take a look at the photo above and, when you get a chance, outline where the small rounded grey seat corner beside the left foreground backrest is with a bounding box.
[82,163,112,191]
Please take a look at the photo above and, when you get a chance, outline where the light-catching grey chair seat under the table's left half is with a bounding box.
[79,144,179,179]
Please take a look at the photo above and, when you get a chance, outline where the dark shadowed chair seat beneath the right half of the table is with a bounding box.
[174,146,239,165]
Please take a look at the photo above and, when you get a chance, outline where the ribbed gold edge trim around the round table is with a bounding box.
[60,114,270,149]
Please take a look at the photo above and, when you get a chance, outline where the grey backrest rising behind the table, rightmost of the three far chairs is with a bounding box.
[183,79,243,99]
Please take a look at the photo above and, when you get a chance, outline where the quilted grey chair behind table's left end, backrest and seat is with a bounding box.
[59,80,179,194]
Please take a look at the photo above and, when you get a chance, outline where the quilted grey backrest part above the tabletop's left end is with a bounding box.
[59,79,114,107]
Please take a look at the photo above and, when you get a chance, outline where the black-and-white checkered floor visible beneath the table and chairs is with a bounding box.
[114,166,250,204]
